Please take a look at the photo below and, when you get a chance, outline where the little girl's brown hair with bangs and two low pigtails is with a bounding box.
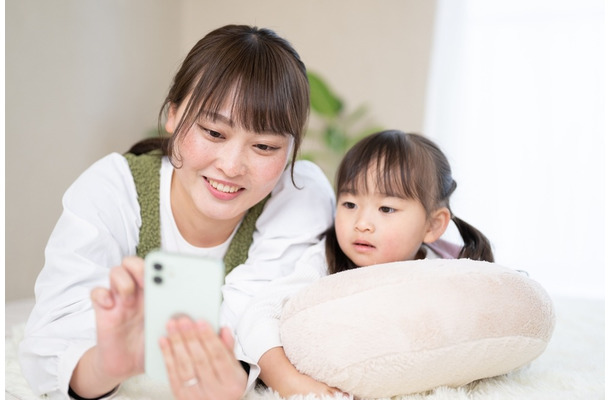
[326,130,494,274]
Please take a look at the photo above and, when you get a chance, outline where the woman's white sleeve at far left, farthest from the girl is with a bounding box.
[19,153,141,398]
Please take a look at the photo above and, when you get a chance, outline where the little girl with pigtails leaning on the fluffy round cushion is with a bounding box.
[237,130,493,396]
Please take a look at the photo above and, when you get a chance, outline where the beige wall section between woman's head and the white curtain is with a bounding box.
[176,0,436,131]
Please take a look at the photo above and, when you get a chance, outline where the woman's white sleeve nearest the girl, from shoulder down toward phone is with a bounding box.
[221,161,335,388]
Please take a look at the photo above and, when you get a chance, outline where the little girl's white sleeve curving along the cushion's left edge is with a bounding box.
[237,240,328,362]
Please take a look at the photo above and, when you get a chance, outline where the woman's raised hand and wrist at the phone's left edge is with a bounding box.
[70,257,144,398]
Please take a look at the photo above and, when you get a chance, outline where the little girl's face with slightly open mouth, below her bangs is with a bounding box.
[335,174,431,267]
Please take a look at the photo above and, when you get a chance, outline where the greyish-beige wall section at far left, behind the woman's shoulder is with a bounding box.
[5,0,180,300]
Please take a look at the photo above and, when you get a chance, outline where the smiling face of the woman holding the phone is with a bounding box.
[166,95,293,228]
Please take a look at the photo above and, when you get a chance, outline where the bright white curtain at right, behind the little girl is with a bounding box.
[424,0,606,297]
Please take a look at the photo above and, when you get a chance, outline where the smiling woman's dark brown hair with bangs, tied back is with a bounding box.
[130,25,309,181]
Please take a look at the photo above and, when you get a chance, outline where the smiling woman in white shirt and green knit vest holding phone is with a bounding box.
[20,25,334,399]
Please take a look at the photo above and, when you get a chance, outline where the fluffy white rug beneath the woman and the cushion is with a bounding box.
[5,298,605,400]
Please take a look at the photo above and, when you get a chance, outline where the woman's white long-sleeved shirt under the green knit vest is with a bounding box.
[19,153,334,398]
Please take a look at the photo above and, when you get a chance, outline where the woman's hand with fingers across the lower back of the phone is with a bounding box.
[159,317,248,400]
